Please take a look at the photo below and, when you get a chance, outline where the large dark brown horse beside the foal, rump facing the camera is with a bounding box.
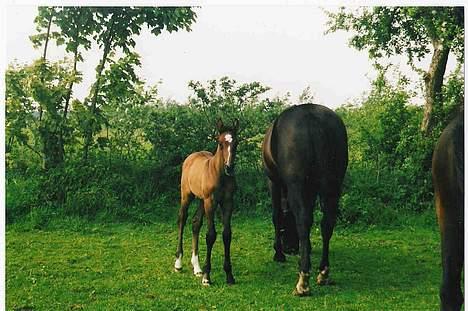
[263,104,348,296]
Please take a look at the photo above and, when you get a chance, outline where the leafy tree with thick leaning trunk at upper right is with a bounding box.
[327,7,464,134]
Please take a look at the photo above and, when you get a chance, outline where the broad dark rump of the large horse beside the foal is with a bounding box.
[269,104,348,194]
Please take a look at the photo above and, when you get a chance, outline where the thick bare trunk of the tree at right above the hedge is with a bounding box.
[421,41,450,135]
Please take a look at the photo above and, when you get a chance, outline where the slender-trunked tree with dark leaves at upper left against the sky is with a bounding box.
[31,7,196,160]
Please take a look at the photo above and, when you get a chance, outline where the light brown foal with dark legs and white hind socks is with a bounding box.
[174,120,239,285]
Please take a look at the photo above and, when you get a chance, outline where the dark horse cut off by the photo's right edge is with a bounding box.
[432,113,465,311]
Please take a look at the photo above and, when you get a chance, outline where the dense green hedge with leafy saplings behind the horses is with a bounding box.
[6,8,464,226]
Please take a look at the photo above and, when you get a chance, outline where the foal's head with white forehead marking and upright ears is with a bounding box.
[216,119,239,176]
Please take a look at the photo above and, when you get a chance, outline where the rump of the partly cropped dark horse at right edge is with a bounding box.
[432,114,464,222]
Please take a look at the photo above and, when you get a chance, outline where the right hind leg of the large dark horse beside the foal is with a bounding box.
[317,196,338,285]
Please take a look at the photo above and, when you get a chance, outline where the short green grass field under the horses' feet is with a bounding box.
[6,217,441,310]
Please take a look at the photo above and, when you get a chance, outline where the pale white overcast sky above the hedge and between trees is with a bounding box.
[2,5,458,108]
